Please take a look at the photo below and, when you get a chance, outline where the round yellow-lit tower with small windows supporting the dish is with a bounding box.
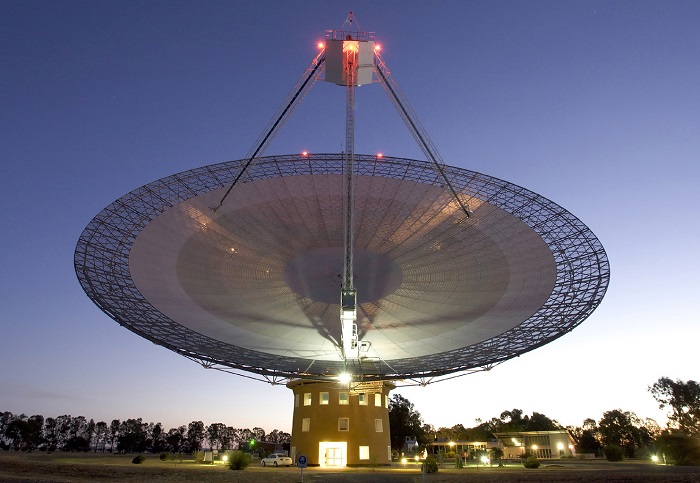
[287,379,396,467]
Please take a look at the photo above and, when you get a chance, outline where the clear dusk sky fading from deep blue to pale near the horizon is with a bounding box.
[0,0,700,431]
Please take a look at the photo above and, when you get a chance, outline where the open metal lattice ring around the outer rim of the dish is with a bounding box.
[75,154,610,383]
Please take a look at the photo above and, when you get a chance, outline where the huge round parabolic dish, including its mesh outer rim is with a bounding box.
[75,154,610,380]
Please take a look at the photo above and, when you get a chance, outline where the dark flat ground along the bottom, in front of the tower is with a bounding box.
[0,452,700,483]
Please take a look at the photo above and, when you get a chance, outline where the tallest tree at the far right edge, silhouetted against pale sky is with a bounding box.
[648,377,700,435]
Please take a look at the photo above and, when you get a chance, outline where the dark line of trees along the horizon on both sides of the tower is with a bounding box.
[0,377,700,458]
